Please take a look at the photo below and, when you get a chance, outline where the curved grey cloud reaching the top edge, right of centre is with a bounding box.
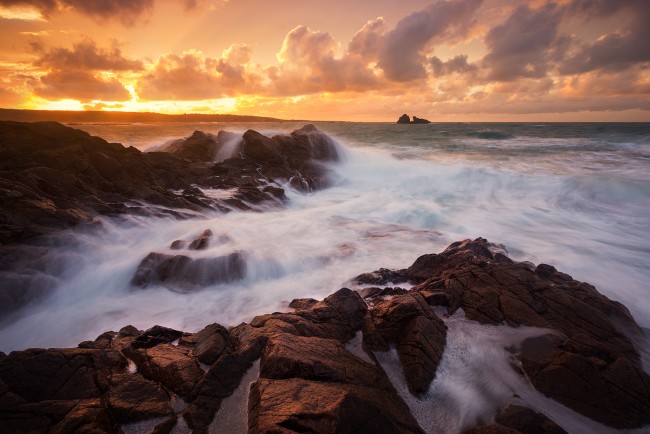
[378,0,482,82]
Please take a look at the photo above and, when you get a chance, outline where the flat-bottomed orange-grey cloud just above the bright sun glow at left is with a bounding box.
[34,71,131,102]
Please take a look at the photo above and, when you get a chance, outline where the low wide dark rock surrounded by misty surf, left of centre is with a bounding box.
[131,249,246,292]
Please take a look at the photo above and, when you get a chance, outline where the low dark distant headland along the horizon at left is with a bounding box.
[0,109,288,123]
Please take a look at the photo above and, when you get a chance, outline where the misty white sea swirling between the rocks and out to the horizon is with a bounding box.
[0,123,650,352]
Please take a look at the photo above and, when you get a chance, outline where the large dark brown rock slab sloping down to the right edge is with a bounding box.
[368,238,650,428]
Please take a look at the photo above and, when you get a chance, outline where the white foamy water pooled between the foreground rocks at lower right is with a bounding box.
[375,310,647,434]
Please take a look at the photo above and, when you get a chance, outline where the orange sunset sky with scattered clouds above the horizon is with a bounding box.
[0,0,650,122]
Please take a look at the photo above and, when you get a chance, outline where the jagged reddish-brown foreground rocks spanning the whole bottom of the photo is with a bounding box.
[0,238,650,433]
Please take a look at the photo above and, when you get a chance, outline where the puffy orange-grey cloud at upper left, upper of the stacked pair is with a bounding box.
[34,39,143,71]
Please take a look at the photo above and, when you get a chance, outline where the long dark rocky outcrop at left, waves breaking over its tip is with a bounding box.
[0,121,340,248]
